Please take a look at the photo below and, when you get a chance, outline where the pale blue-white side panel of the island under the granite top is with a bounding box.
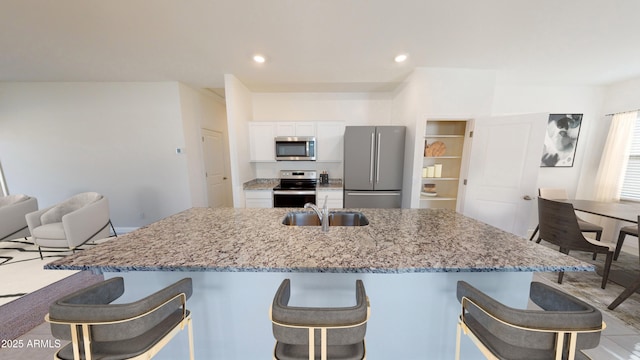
[104,271,533,360]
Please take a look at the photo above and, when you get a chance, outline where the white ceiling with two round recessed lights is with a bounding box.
[0,0,640,91]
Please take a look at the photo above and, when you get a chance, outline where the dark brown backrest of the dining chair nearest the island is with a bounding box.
[538,197,604,251]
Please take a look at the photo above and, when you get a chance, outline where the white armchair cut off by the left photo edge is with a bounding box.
[0,195,38,241]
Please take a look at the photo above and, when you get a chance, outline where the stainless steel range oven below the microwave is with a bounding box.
[273,170,318,207]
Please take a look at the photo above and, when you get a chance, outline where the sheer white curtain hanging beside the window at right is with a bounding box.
[595,111,638,201]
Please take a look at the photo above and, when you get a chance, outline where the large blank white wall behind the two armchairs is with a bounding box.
[0,82,190,228]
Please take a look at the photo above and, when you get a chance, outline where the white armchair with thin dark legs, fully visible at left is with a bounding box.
[26,192,117,259]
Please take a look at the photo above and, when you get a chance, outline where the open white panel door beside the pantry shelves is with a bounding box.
[463,114,549,236]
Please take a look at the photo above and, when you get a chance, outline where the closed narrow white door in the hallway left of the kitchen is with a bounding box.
[202,129,230,207]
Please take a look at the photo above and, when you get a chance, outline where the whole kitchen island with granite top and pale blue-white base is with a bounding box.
[46,208,594,360]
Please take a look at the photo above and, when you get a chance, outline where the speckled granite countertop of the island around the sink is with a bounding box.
[45,208,594,273]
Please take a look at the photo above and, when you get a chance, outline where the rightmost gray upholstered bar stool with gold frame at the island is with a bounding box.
[456,281,605,360]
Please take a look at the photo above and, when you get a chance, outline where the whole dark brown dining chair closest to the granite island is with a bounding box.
[538,197,614,289]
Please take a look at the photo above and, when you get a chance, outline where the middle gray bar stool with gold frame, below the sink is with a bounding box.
[270,279,370,360]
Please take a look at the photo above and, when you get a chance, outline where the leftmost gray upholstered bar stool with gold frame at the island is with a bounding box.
[45,277,194,360]
